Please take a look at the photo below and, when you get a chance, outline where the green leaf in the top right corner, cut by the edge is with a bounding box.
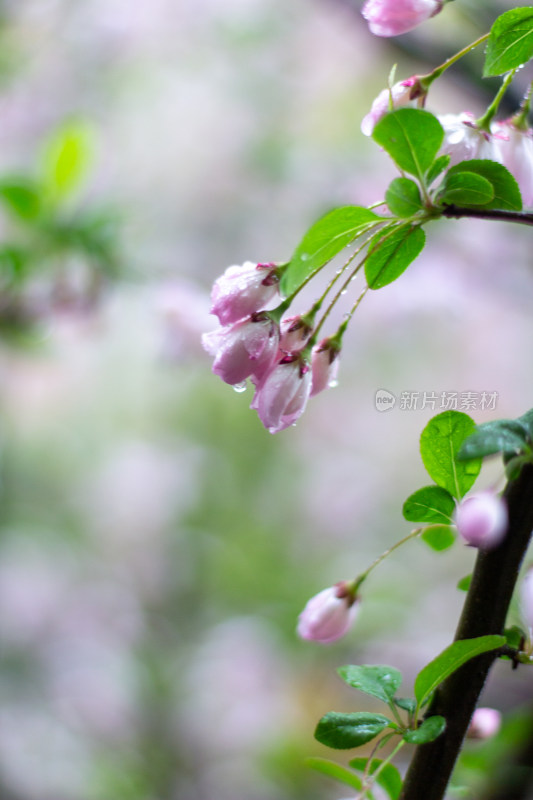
[483,7,533,78]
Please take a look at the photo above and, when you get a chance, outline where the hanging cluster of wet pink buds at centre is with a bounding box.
[202,261,340,433]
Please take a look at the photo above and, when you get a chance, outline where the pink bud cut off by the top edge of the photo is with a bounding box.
[362,0,444,36]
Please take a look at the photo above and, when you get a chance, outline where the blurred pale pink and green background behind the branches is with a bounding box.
[0,0,533,800]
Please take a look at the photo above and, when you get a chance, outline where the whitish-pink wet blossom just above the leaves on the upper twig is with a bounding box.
[439,111,502,165]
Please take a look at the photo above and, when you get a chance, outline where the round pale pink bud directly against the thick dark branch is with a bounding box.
[454,491,508,550]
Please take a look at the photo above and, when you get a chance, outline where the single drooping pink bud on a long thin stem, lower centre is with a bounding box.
[296,582,359,644]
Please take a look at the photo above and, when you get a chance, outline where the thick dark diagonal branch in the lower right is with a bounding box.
[400,464,533,800]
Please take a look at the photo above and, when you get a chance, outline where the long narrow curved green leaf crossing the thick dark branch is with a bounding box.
[415,636,505,705]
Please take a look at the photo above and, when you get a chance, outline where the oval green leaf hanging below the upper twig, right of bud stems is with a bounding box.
[365,225,426,289]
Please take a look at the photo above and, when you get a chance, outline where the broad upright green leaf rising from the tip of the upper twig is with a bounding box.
[372,108,444,181]
